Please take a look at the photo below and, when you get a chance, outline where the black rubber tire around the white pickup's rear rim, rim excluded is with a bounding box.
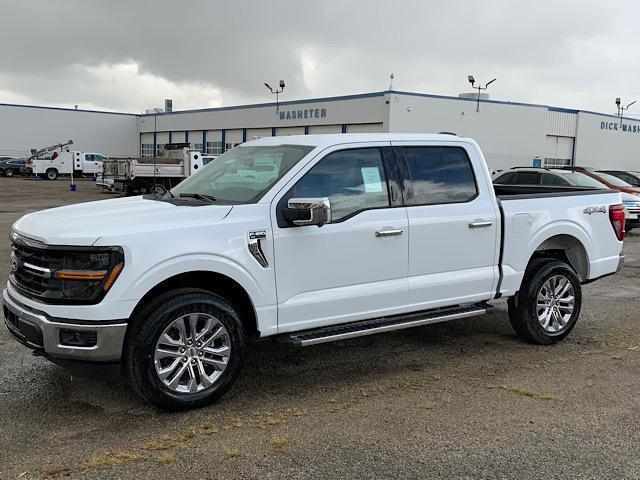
[507,259,582,345]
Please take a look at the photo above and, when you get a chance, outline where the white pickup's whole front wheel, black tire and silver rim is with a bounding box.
[124,289,245,410]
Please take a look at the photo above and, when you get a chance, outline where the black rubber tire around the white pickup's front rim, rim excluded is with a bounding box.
[123,288,246,411]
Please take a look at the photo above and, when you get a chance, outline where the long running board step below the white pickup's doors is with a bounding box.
[277,303,494,347]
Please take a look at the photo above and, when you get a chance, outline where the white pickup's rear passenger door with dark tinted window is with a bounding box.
[393,142,500,310]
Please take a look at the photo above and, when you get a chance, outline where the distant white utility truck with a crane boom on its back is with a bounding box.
[29,150,107,180]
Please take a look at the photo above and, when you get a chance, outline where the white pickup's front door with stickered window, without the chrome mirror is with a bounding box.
[272,142,408,332]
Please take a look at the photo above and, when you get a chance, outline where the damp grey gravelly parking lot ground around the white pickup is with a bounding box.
[0,178,640,479]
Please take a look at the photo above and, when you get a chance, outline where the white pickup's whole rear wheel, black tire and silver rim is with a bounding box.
[508,260,582,345]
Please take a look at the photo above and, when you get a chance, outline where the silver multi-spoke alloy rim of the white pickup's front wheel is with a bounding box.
[154,313,231,393]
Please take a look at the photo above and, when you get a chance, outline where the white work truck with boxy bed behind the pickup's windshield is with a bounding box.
[101,143,216,195]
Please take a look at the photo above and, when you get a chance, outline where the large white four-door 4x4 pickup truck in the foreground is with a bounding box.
[4,134,625,409]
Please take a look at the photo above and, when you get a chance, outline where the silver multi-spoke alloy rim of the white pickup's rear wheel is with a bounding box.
[536,275,575,335]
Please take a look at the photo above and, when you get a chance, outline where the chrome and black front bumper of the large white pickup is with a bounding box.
[2,289,127,362]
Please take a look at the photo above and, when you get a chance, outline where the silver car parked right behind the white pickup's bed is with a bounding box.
[493,167,640,231]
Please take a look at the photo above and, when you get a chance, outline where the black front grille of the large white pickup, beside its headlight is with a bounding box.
[10,238,64,297]
